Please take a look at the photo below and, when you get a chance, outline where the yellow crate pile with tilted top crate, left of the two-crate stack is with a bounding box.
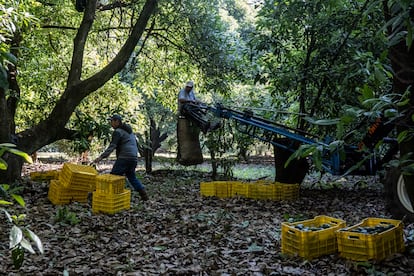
[48,163,98,205]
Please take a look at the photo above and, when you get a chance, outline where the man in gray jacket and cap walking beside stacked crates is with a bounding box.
[94,114,148,200]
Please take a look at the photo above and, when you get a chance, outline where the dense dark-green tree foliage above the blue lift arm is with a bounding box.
[255,1,389,135]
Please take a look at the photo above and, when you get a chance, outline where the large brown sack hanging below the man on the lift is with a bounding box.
[177,118,203,166]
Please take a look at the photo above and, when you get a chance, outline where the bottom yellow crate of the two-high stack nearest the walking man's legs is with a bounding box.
[92,189,131,214]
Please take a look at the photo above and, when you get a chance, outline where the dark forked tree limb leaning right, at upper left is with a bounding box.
[18,0,157,153]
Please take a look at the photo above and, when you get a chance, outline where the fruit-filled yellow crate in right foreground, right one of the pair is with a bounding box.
[336,218,404,261]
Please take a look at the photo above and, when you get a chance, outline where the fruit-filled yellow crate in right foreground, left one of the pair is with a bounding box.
[282,216,346,260]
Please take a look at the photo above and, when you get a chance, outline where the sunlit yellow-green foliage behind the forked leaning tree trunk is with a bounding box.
[2,0,251,162]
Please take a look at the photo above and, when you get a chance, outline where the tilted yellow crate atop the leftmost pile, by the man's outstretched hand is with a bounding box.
[59,163,98,191]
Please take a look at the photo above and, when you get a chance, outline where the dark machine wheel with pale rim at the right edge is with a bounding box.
[382,167,414,221]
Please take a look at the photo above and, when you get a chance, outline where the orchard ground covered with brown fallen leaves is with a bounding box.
[0,161,414,275]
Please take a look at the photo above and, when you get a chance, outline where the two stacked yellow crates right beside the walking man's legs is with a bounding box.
[92,174,131,214]
